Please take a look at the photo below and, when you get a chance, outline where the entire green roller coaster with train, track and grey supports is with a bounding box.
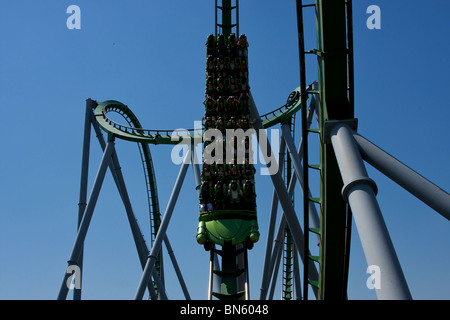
[58,0,450,300]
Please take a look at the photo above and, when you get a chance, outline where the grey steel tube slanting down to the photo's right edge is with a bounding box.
[353,132,450,220]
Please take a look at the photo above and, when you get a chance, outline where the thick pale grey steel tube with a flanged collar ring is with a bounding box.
[331,123,412,300]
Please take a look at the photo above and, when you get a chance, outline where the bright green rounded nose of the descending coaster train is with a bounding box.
[197,210,259,249]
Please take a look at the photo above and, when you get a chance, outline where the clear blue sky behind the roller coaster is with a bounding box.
[0,0,450,299]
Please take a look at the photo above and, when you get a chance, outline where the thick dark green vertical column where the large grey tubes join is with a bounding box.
[316,0,354,299]
